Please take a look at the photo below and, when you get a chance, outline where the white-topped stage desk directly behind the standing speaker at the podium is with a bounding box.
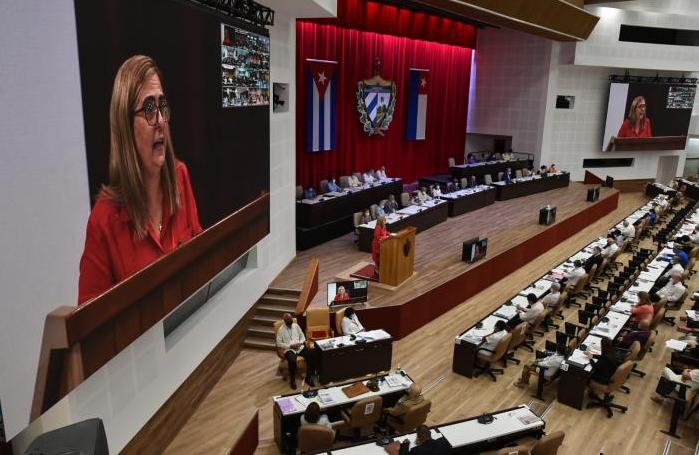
[357,199,449,253]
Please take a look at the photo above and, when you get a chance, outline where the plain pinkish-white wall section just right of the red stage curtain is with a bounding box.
[466,28,551,164]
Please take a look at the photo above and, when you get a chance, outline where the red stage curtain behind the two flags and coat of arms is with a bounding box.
[296,20,472,188]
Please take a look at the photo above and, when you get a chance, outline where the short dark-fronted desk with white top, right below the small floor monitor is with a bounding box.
[315,330,393,384]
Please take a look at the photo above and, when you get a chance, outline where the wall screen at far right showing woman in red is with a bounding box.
[602,82,697,151]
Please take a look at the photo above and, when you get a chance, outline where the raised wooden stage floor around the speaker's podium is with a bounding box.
[271,183,615,307]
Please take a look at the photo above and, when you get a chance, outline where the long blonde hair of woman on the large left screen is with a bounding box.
[100,55,180,239]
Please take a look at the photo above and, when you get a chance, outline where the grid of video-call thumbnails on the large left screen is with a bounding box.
[221,24,269,107]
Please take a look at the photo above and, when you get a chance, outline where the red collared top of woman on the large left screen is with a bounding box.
[78,161,202,305]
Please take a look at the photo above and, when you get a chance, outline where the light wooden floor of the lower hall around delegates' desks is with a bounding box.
[167,193,699,455]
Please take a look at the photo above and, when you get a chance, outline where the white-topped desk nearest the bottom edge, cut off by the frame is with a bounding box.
[321,405,546,455]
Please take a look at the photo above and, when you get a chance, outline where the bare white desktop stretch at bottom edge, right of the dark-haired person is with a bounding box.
[439,405,544,448]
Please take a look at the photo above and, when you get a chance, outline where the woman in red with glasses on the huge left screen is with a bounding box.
[78,55,202,305]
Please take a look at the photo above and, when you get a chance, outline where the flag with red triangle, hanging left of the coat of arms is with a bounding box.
[306,59,337,152]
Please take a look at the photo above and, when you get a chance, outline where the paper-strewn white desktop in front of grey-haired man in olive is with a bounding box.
[273,372,413,415]
